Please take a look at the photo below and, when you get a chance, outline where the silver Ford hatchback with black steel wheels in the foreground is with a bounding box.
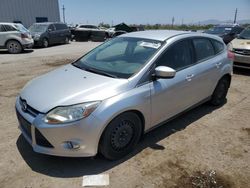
[16,31,232,160]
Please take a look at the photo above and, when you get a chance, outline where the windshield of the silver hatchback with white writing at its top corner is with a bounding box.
[73,37,162,78]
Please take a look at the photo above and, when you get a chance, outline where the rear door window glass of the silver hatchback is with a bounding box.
[193,38,214,61]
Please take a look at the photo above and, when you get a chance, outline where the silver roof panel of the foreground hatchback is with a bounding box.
[119,30,191,41]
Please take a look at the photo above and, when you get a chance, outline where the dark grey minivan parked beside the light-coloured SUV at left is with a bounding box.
[29,22,71,48]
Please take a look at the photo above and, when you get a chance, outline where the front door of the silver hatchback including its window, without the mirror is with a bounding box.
[151,40,199,126]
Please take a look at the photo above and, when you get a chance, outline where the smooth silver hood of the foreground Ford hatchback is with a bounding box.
[20,64,129,113]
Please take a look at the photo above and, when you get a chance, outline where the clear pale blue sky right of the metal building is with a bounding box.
[59,0,250,25]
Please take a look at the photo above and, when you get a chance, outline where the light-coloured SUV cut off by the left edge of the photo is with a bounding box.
[0,23,34,54]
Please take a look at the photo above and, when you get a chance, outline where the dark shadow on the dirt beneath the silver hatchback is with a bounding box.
[16,104,223,178]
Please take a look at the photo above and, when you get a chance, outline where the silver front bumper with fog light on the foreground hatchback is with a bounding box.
[16,98,103,157]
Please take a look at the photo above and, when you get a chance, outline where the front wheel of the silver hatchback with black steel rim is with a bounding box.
[99,112,142,160]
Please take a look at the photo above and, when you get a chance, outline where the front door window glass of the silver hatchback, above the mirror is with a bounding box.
[157,40,194,70]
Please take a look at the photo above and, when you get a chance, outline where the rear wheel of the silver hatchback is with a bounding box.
[210,77,230,106]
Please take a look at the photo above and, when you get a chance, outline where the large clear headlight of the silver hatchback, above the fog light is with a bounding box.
[44,101,100,124]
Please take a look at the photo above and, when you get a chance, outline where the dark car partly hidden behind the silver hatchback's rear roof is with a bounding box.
[204,24,244,44]
